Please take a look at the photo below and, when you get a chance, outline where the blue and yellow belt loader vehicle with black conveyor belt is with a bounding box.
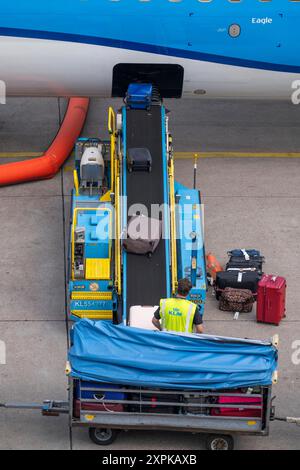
[69,85,207,324]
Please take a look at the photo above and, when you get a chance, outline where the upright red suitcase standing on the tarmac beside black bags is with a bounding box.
[256,274,286,325]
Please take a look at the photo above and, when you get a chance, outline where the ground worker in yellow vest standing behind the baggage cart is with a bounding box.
[152,279,203,333]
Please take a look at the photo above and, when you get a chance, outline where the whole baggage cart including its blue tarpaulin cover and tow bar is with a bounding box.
[0,320,279,450]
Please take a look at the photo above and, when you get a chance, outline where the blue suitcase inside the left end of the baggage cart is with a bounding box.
[75,381,126,400]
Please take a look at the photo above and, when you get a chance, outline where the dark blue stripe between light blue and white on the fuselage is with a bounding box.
[0,27,300,73]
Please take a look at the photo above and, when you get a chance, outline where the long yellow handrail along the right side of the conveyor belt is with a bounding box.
[169,159,178,295]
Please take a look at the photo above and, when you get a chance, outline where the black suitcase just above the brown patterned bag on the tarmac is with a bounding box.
[216,271,261,299]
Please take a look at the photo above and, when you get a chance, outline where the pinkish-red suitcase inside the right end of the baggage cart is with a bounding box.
[211,397,262,418]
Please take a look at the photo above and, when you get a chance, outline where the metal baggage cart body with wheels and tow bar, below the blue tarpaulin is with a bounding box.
[0,379,274,450]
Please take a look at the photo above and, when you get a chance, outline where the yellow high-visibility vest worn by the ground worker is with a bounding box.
[160,298,197,333]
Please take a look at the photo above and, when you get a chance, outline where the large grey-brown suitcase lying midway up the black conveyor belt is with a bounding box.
[123,215,162,256]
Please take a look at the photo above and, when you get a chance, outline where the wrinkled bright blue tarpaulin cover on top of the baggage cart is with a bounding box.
[69,320,277,390]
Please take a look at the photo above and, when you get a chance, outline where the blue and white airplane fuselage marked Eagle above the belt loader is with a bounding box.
[0,0,300,98]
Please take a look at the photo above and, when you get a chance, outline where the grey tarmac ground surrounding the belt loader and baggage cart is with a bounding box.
[0,99,300,450]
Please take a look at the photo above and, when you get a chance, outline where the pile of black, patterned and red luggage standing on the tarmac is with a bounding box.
[211,249,286,325]
